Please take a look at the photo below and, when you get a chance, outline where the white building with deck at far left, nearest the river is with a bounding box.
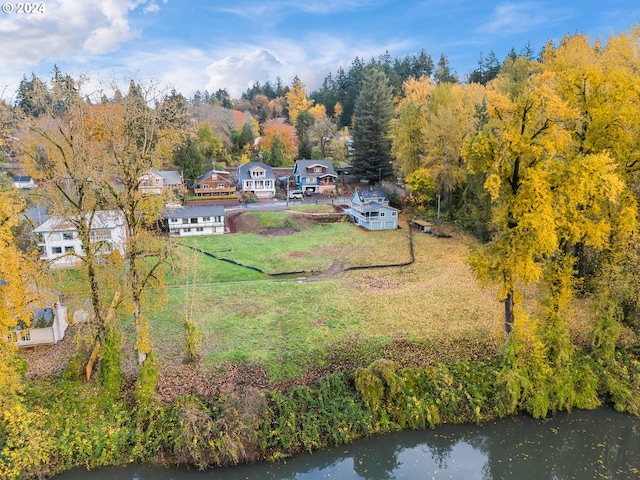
[15,302,69,347]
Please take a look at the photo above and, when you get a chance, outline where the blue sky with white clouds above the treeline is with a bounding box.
[0,0,640,99]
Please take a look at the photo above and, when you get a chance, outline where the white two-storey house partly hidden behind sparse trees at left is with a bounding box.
[33,210,127,267]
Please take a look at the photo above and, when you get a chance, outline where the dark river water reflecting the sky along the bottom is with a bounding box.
[56,408,640,480]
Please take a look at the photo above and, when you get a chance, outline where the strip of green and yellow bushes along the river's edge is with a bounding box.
[7,340,638,478]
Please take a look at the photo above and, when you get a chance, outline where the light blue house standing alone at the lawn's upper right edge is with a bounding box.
[345,188,399,230]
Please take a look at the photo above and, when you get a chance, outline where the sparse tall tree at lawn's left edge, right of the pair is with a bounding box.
[101,81,186,372]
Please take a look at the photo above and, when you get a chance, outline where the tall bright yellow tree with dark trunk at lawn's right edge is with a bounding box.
[463,53,624,333]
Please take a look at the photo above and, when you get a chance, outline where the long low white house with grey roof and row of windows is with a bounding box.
[164,205,224,237]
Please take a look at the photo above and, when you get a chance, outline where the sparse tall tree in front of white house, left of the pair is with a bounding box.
[22,77,115,354]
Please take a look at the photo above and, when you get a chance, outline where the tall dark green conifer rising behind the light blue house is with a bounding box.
[352,68,394,183]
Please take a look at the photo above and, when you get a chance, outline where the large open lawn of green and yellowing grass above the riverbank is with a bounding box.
[153,213,501,379]
